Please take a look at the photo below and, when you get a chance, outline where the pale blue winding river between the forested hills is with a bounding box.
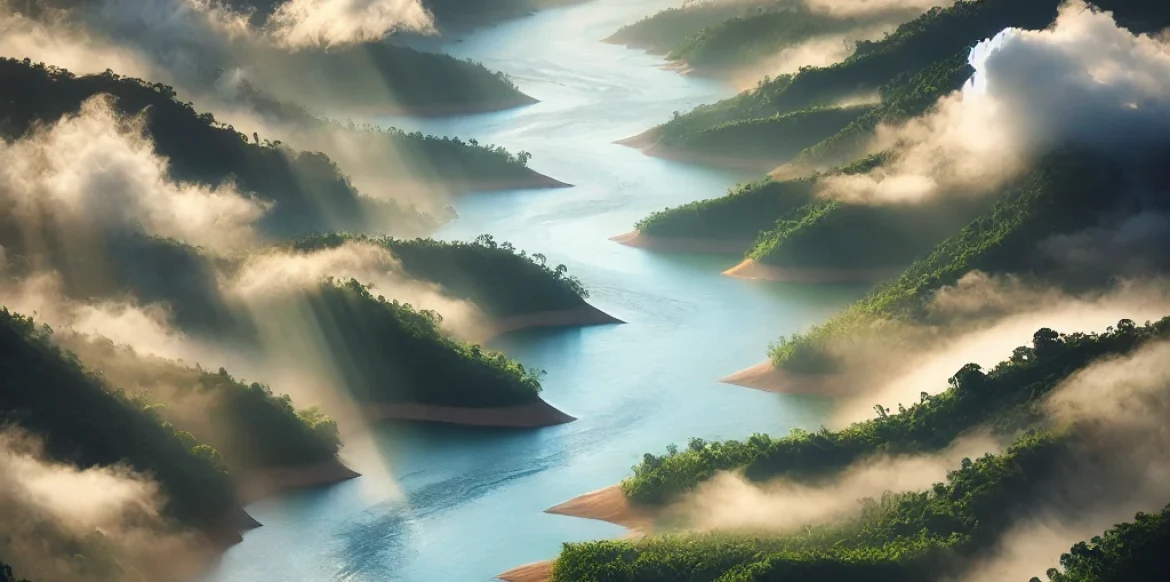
[207,0,862,582]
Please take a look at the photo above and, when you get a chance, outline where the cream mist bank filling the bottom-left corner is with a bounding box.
[0,427,212,582]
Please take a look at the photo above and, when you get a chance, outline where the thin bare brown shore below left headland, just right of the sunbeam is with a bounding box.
[362,399,577,429]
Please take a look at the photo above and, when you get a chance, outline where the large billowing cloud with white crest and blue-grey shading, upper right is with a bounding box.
[821,0,1170,204]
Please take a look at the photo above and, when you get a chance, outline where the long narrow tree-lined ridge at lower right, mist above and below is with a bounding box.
[622,317,1170,505]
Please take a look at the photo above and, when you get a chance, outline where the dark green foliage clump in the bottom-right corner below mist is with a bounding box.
[1048,506,1170,582]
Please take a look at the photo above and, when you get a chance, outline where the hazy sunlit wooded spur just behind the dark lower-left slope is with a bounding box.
[70,335,340,474]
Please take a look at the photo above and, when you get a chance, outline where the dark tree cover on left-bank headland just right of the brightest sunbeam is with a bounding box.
[309,280,544,408]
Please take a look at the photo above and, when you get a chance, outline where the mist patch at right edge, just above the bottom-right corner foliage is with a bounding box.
[963,342,1170,582]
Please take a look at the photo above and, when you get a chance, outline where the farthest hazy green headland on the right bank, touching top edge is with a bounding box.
[606,0,792,54]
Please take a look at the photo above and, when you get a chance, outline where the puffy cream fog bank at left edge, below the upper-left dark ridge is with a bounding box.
[0,96,268,254]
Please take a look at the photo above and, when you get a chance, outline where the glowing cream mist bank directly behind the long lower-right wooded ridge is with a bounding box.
[826,272,1170,426]
